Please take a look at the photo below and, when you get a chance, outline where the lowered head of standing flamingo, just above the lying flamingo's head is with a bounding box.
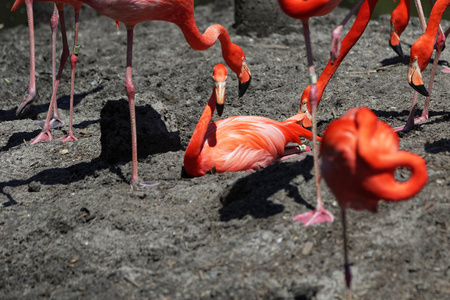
[223,44,252,97]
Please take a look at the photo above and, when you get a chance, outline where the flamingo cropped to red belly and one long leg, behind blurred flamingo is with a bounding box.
[278,0,341,225]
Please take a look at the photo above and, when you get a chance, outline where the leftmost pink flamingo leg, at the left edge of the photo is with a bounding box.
[16,0,36,117]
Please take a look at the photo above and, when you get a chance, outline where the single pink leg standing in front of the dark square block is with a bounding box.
[125,27,158,188]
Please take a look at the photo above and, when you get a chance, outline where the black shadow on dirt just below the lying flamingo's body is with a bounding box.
[219,155,313,221]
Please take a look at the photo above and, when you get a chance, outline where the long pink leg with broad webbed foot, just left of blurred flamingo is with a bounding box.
[294,22,334,226]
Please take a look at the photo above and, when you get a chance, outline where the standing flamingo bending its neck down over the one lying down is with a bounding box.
[72,0,251,188]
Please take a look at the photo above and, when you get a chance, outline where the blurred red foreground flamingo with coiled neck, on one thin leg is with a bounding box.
[320,107,428,298]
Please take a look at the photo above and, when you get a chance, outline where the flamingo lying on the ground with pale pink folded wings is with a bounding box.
[184,64,321,176]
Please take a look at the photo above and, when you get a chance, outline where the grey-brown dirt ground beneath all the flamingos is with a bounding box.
[0,5,450,299]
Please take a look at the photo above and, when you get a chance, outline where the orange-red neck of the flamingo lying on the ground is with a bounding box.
[185,90,216,159]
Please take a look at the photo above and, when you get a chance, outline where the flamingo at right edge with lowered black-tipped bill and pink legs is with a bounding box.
[394,0,450,131]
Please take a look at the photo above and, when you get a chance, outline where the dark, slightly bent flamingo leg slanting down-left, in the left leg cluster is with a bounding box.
[31,6,69,144]
